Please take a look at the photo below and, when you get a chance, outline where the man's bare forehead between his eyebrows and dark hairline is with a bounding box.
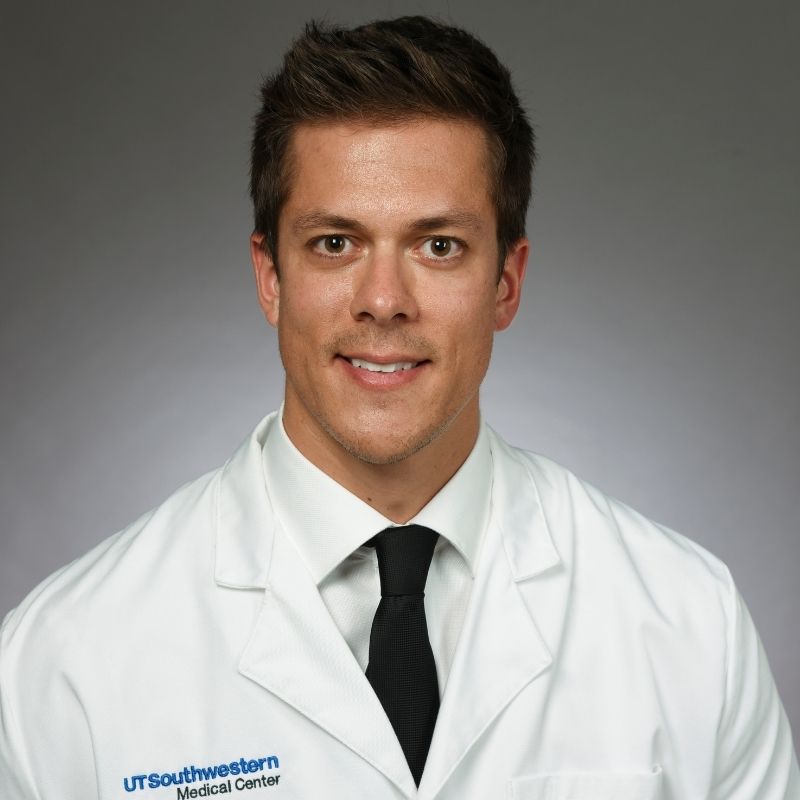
[284,119,494,222]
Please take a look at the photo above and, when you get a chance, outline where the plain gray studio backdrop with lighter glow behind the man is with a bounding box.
[0,0,800,744]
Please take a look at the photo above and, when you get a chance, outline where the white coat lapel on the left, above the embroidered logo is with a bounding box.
[219,414,416,797]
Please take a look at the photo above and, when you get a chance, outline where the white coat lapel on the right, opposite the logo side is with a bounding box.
[419,435,560,798]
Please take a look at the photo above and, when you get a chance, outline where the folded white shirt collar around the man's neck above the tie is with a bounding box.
[263,409,492,585]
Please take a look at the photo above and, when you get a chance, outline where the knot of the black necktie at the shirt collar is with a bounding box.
[369,525,439,597]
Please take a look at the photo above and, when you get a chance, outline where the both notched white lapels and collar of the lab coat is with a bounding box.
[216,415,560,798]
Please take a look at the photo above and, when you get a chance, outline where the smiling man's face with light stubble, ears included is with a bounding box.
[252,120,527,464]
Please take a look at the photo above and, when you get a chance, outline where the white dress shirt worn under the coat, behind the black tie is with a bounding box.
[263,412,492,695]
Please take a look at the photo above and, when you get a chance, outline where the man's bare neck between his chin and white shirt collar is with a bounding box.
[284,403,479,524]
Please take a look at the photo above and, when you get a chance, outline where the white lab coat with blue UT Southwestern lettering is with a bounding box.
[0,416,800,800]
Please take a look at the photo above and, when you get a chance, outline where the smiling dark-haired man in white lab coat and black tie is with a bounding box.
[0,18,800,800]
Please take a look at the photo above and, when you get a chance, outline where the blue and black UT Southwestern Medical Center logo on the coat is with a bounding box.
[122,756,281,800]
